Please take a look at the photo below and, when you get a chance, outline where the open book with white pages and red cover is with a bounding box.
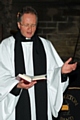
[17,74,46,83]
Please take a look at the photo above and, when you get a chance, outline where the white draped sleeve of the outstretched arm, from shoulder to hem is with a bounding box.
[43,42,69,117]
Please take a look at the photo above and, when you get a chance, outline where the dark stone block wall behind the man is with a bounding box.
[0,0,80,62]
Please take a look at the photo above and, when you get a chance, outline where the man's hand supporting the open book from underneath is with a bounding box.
[17,80,37,89]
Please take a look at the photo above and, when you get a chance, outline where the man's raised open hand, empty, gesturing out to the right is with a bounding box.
[61,58,77,74]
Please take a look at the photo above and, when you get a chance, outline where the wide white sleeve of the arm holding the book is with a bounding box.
[0,40,19,120]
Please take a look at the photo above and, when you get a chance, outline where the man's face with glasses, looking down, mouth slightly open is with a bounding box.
[18,13,37,38]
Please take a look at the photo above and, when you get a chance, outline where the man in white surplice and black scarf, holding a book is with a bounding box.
[0,7,77,120]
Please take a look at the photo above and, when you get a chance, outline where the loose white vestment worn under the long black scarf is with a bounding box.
[0,36,69,120]
